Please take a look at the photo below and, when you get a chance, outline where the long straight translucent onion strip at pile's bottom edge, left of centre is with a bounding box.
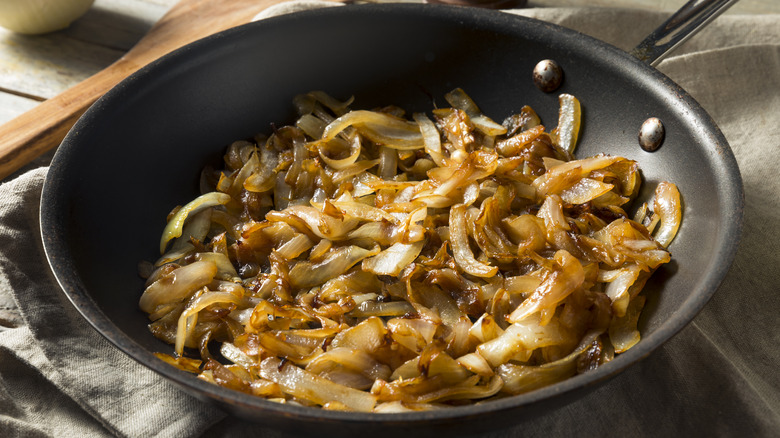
[260,357,376,412]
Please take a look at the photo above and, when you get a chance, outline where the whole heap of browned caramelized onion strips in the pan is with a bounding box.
[139,89,682,412]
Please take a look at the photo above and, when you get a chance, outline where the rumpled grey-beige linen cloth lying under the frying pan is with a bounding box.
[0,1,780,438]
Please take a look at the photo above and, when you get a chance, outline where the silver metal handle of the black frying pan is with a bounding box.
[630,0,738,66]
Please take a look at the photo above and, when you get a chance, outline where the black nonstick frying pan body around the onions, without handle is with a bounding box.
[41,4,743,436]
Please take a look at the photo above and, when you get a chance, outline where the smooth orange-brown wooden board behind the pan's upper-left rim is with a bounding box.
[0,0,336,178]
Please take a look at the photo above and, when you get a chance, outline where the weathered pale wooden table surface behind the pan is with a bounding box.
[0,0,780,180]
